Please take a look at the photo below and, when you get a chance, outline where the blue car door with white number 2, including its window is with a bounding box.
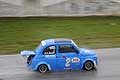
[56,44,80,70]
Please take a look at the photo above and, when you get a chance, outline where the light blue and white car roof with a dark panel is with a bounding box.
[42,38,72,45]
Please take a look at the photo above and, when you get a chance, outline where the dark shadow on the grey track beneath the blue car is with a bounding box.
[26,70,97,80]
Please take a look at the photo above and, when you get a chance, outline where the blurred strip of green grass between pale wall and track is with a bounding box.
[0,17,120,54]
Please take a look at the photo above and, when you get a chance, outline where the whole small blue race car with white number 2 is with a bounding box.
[21,38,98,73]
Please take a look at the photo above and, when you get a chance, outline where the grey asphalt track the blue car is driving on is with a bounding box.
[0,48,120,80]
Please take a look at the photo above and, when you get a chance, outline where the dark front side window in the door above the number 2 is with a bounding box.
[58,45,76,53]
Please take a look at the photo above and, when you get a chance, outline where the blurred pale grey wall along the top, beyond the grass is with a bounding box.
[0,0,120,17]
